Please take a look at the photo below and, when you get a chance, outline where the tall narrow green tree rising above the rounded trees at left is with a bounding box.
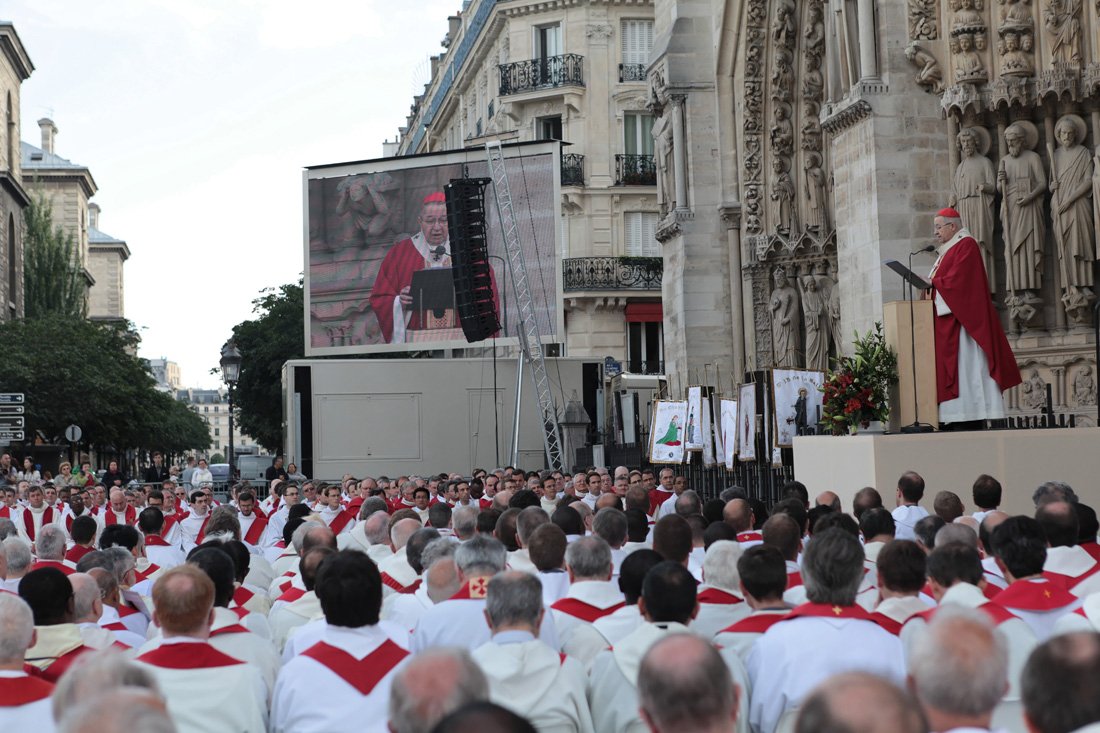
[23,192,88,318]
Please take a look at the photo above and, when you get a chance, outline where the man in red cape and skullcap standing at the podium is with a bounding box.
[932,208,1023,424]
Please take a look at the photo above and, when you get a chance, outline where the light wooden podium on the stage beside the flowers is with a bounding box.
[882,300,939,433]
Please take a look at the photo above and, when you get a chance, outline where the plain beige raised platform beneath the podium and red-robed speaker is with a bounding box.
[794,428,1100,515]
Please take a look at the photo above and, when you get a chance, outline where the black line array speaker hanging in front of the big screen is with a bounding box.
[443,178,501,343]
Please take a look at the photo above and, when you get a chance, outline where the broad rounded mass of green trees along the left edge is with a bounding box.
[0,315,210,452]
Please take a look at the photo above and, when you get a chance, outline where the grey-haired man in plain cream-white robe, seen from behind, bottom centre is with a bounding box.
[473,572,593,733]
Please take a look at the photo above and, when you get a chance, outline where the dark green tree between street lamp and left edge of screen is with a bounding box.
[233,280,306,452]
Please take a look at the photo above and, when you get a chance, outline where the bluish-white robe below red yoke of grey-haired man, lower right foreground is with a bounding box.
[747,616,905,733]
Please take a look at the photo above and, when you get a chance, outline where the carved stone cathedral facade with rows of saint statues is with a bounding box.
[649,0,1100,425]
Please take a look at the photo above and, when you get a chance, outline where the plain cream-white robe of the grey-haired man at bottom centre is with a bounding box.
[473,631,593,733]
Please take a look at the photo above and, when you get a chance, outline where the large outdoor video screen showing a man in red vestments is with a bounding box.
[305,142,563,355]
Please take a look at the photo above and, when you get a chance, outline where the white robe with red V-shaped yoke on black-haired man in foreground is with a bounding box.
[271,626,408,733]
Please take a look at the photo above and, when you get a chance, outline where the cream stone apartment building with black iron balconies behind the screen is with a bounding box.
[398,0,664,373]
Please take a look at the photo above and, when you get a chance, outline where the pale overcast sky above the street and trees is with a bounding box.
[9,0,461,387]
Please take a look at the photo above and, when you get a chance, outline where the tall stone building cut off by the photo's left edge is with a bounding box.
[0,22,34,320]
